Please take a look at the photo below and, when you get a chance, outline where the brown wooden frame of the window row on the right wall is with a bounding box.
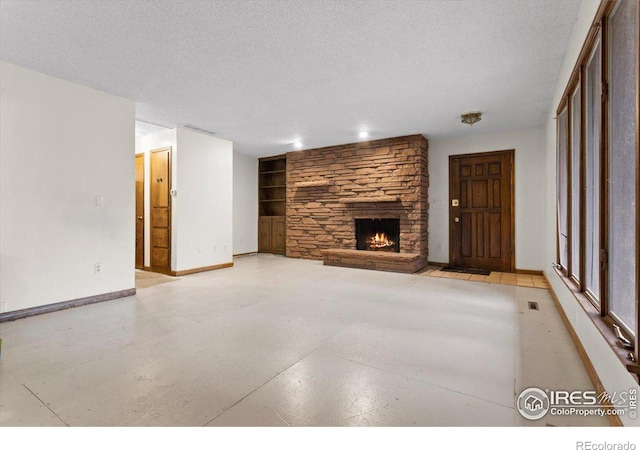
[556,0,640,374]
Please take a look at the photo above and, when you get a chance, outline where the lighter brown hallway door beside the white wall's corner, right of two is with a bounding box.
[150,148,171,273]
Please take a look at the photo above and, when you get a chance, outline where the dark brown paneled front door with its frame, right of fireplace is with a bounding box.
[449,150,515,272]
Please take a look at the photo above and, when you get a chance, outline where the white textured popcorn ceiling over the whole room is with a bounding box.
[0,0,580,156]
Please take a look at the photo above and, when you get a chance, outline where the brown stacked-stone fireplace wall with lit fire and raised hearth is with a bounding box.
[286,135,429,272]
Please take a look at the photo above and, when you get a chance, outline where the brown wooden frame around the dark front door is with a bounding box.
[449,149,516,273]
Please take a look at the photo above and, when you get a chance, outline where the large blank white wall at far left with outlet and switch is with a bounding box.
[0,62,135,311]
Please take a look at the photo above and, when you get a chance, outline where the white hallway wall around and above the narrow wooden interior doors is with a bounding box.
[135,128,177,267]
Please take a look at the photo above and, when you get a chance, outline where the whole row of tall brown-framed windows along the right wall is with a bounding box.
[557,0,640,361]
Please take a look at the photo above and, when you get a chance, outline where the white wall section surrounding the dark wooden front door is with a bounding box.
[429,127,545,270]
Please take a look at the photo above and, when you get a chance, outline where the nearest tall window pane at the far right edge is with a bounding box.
[608,1,638,334]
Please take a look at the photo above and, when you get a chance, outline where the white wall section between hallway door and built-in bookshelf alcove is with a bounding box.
[172,128,233,271]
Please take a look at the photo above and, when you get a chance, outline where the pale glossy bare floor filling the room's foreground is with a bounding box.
[0,255,608,426]
